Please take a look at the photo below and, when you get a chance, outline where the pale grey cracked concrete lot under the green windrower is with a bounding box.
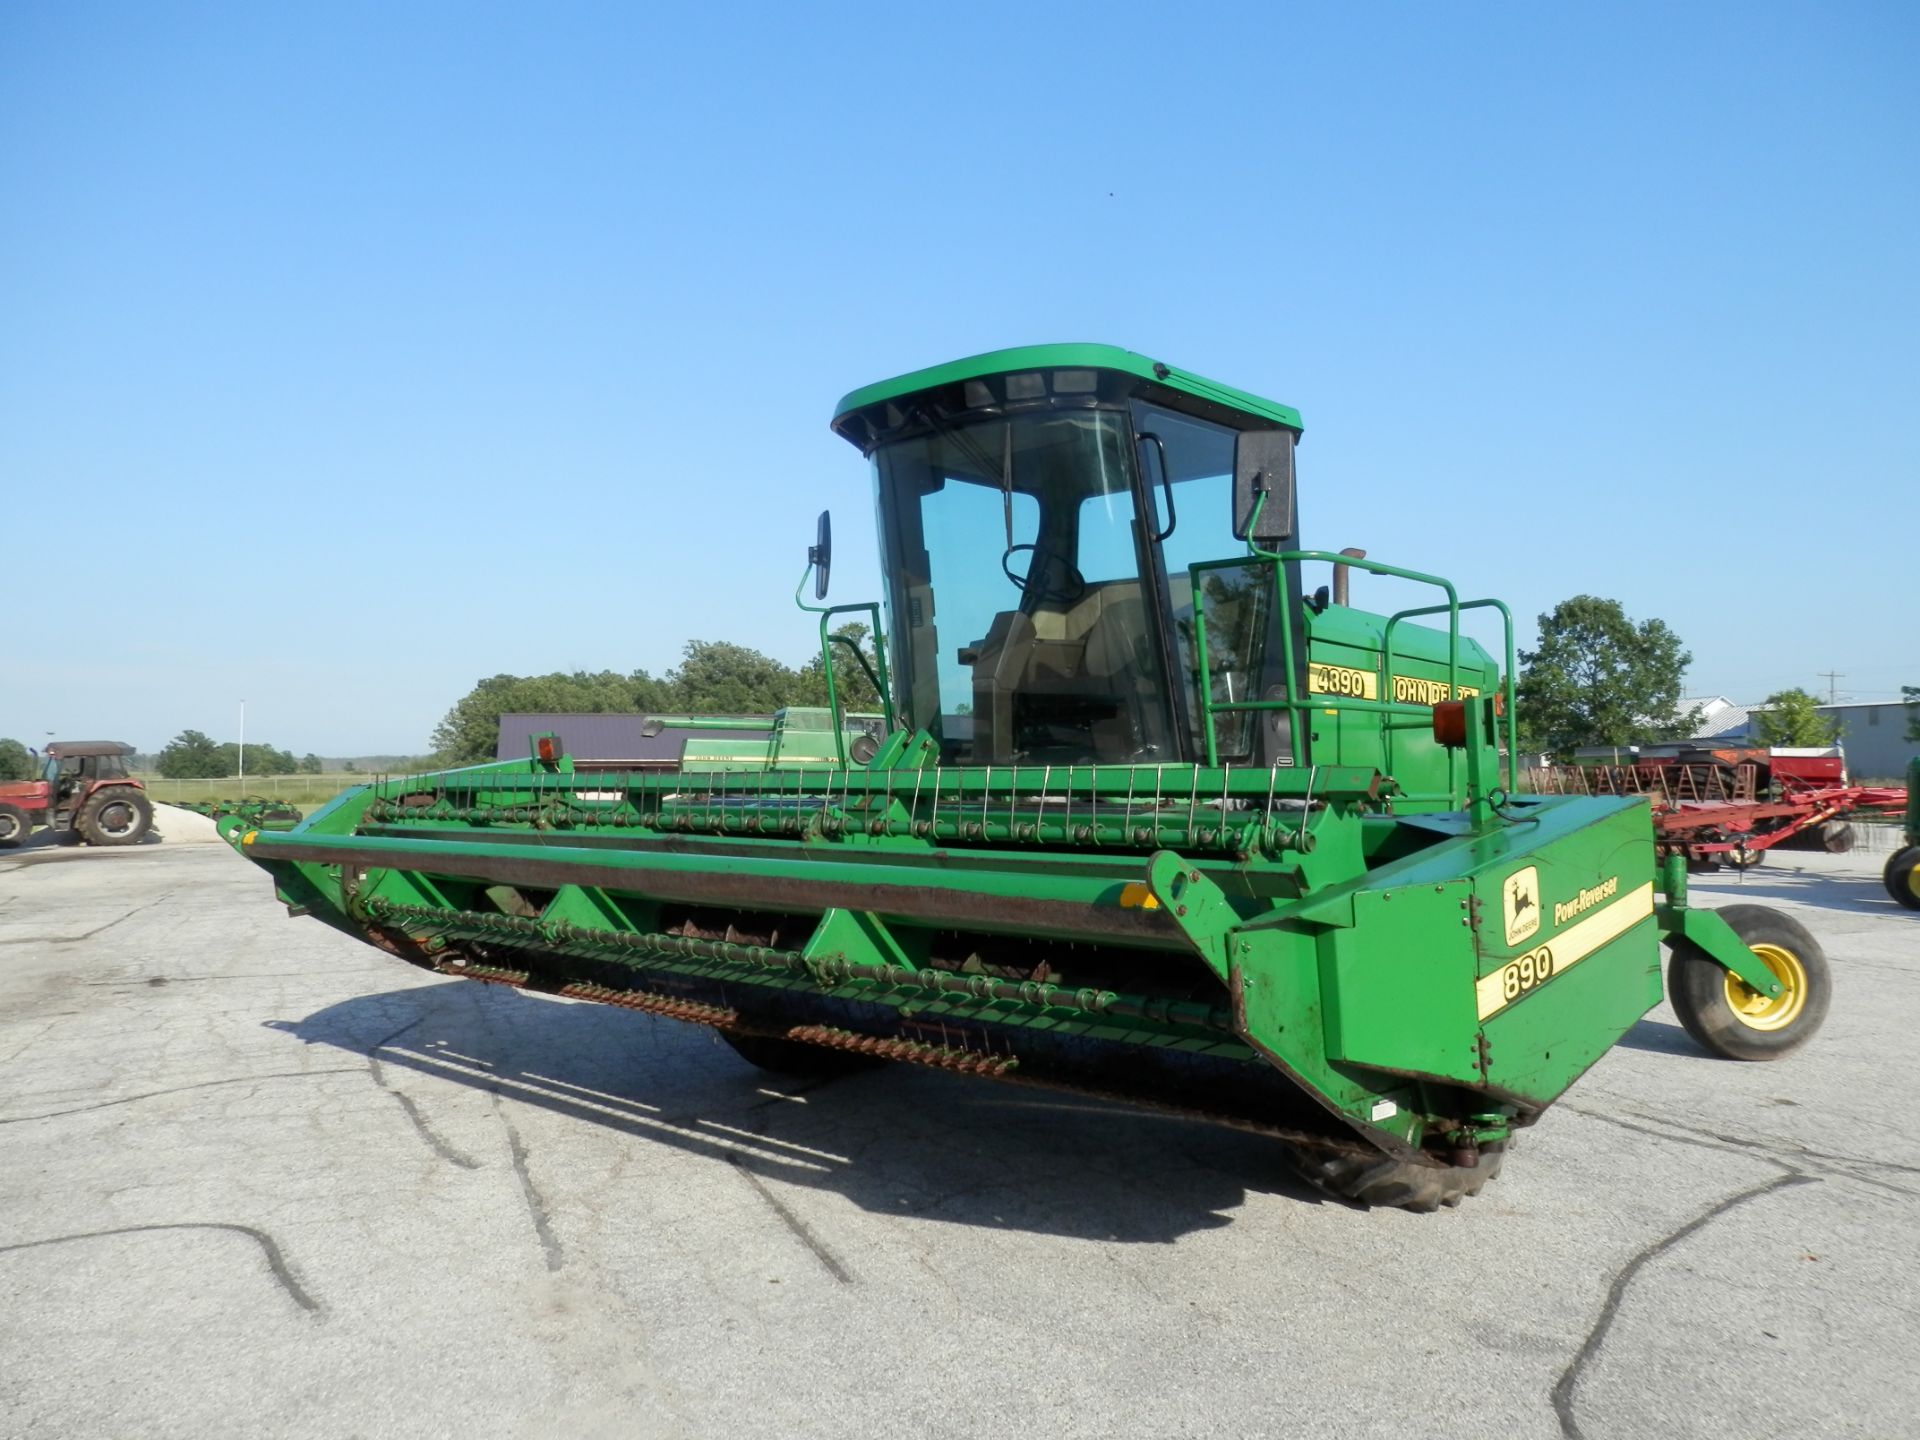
[0,829,1920,1440]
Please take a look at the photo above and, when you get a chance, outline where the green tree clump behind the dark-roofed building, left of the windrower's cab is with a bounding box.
[432,624,879,770]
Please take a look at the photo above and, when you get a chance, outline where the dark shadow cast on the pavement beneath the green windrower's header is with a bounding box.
[269,981,1325,1244]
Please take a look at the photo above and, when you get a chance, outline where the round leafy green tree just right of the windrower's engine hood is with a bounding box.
[1519,595,1699,753]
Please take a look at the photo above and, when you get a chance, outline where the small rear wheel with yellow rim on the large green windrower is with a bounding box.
[1667,904,1834,1060]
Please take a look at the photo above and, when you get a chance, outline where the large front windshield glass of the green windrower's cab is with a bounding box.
[876,409,1177,764]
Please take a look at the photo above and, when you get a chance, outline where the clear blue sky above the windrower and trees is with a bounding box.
[0,0,1920,755]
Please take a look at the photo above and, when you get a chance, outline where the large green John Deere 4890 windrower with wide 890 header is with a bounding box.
[223,346,1828,1208]
